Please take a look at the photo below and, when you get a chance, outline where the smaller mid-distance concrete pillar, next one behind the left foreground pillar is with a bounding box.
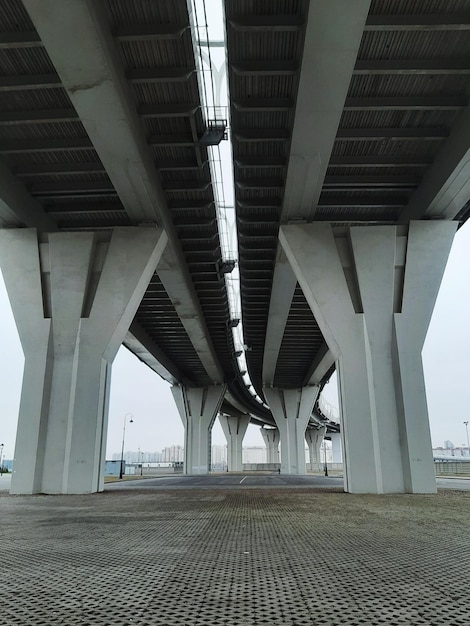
[171,385,226,474]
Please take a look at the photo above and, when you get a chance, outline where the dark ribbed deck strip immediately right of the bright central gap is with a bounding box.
[225,1,308,393]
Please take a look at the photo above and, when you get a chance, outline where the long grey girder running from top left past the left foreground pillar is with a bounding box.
[24,0,224,384]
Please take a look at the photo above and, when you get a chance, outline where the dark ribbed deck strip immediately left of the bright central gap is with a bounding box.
[103,0,242,384]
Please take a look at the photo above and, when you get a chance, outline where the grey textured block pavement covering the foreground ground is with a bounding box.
[0,488,470,626]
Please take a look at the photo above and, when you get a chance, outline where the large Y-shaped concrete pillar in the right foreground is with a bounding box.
[280,221,457,493]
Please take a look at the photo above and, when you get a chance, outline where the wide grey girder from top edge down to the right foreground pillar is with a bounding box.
[282,0,371,223]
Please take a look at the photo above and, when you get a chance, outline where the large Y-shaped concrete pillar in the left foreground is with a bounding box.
[0,227,167,494]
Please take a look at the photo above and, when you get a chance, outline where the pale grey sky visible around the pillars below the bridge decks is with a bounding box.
[0,224,470,458]
